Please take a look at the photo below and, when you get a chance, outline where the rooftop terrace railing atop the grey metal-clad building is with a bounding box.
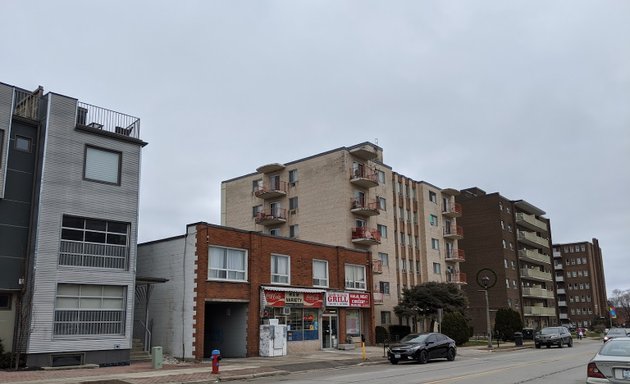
[77,102,140,139]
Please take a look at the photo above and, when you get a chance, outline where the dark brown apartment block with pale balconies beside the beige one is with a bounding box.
[456,187,558,334]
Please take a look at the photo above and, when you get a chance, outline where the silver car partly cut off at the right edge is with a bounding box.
[586,337,630,383]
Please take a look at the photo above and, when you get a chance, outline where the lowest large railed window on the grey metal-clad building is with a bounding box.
[53,284,126,336]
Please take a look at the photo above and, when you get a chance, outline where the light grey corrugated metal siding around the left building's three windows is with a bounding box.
[28,94,141,353]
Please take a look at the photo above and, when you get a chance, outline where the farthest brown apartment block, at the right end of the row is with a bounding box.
[553,239,608,328]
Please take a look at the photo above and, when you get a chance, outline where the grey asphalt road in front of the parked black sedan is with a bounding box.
[232,341,601,384]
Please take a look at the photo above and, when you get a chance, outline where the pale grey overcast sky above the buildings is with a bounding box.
[0,0,630,292]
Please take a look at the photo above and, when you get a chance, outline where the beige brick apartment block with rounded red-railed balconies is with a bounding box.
[221,142,463,325]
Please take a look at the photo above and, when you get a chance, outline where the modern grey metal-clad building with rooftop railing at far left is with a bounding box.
[0,83,145,366]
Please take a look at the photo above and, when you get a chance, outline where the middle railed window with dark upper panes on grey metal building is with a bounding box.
[59,215,130,269]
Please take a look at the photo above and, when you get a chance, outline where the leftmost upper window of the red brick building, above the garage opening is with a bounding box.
[208,247,247,281]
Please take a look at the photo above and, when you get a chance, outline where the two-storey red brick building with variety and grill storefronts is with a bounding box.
[136,223,374,359]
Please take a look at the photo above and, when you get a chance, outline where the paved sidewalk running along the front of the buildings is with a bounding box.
[0,343,564,384]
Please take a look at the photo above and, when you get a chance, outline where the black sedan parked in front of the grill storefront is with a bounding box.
[387,332,457,364]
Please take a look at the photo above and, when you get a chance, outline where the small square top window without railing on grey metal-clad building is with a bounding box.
[83,145,122,185]
